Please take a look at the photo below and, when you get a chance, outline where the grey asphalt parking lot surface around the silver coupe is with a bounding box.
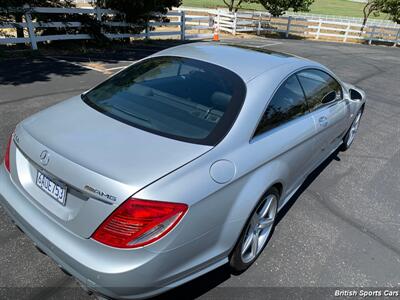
[0,38,400,299]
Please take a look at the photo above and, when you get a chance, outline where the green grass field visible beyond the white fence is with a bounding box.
[182,0,387,19]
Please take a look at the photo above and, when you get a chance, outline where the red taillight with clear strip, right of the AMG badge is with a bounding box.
[92,198,188,248]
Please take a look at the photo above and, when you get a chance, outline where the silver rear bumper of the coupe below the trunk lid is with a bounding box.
[0,165,227,299]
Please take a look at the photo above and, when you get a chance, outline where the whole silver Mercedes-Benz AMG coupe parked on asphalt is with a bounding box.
[0,43,365,299]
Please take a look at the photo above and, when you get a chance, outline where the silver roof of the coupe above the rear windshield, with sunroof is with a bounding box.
[154,42,318,82]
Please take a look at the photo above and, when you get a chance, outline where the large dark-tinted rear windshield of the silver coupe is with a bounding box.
[82,57,246,145]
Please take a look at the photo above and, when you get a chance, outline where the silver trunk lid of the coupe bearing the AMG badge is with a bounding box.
[12,97,211,238]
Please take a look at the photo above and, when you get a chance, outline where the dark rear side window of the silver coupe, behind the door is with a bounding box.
[254,75,308,136]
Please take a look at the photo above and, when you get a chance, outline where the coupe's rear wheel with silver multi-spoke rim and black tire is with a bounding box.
[229,187,280,274]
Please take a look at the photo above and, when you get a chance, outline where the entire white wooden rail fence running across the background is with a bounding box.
[0,7,400,49]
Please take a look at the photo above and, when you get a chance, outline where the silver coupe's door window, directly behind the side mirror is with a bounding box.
[297,69,343,110]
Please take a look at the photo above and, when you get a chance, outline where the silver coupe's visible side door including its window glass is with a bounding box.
[297,69,349,164]
